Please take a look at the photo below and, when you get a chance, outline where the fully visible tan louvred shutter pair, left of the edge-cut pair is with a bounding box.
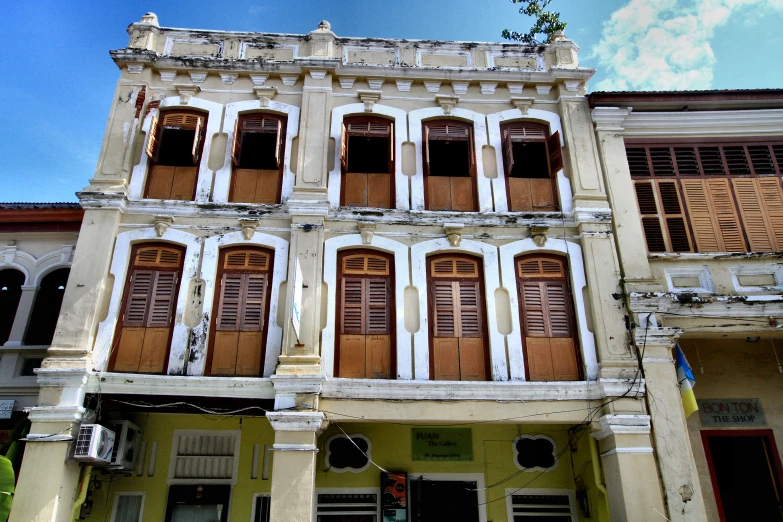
[681,178,746,252]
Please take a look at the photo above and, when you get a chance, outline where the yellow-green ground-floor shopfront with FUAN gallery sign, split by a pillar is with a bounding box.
[82,412,620,522]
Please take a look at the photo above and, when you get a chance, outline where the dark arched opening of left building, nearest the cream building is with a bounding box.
[24,268,71,346]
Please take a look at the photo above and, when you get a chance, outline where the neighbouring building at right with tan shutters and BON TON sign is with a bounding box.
[588,89,783,521]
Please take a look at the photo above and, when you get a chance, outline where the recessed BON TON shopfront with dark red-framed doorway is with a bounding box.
[680,336,783,522]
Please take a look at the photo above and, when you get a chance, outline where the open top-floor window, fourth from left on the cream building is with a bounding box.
[423,120,478,212]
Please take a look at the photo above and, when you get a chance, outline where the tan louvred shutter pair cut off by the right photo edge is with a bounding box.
[732,177,783,252]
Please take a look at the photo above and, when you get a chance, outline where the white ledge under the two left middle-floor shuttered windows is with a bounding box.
[87,373,275,399]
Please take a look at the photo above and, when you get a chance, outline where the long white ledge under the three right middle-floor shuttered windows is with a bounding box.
[321,378,644,402]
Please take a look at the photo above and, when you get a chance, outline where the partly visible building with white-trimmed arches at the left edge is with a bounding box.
[0,203,84,428]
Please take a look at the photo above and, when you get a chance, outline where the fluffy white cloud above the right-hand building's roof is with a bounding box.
[592,0,783,90]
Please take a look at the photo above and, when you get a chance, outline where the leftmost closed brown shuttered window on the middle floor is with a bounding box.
[109,243,185,373]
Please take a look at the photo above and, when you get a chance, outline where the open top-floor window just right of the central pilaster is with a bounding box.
[340,116,394,208]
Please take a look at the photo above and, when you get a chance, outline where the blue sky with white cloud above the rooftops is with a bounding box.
[0,0,783,201]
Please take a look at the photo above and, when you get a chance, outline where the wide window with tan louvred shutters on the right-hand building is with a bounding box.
[626,141,783,252]
